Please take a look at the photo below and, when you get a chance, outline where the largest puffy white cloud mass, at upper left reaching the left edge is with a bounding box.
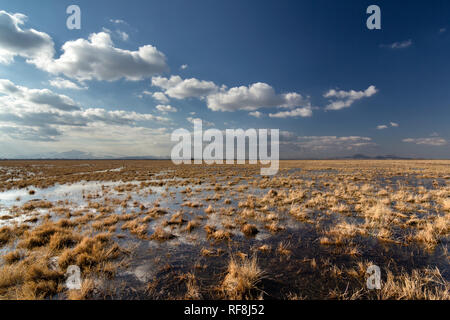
[0,11,167,81]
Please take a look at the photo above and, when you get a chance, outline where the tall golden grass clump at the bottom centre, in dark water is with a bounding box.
[221,256,264,300]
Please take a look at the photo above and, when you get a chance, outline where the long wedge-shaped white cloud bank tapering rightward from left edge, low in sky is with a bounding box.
[0,79,168,140]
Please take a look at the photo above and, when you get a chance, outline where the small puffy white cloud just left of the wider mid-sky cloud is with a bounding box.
[152,76,218,99]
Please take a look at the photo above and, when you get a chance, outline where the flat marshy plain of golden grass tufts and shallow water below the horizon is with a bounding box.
[0,160,450,299]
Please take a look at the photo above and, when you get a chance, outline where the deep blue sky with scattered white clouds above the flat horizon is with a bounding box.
[0,0,450,159]
